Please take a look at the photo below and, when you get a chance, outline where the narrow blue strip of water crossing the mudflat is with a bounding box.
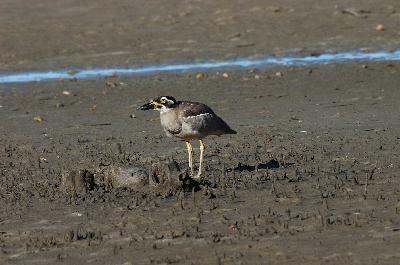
[0,50,400,84]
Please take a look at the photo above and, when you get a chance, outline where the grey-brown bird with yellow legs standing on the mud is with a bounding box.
[138,96,237,179]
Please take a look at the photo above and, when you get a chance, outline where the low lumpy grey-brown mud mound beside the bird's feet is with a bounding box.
[60,160,200,200]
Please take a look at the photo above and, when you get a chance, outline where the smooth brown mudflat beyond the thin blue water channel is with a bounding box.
[0,0,400,71]
